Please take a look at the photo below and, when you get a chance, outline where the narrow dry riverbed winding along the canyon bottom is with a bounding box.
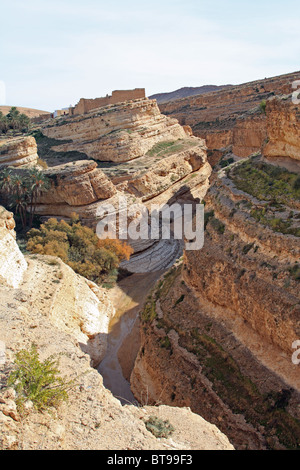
[98,271,164,404]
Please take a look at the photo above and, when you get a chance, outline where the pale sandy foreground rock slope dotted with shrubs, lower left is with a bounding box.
[0,214,234,451]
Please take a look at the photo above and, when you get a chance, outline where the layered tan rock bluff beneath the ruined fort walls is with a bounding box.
[32,106,211,272]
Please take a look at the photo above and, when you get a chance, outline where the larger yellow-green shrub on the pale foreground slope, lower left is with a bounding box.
[8,345,74,411]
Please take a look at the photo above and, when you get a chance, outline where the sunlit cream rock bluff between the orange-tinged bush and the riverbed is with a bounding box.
[21,256,115,367]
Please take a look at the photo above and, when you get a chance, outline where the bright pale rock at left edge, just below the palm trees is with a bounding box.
[0,206,27,288]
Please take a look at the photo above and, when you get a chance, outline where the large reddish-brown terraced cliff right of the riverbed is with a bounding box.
[131,157,300,449]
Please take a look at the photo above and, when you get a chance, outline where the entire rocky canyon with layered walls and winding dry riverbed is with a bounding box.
[0,72,300,450]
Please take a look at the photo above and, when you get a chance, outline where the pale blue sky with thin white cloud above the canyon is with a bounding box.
[0,0,300,111]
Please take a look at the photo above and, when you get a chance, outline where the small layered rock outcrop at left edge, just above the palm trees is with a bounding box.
[0,137,38,169]
